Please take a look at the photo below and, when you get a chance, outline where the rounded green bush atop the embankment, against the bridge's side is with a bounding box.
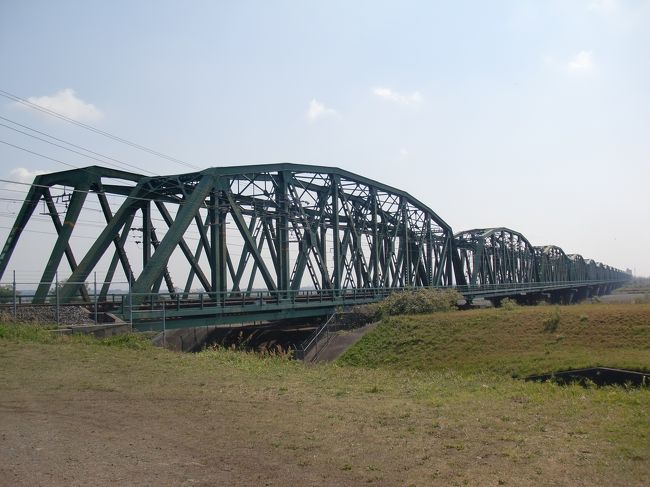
[377,288,463,317]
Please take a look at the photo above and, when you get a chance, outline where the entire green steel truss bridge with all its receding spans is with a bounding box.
[0,164,629,329]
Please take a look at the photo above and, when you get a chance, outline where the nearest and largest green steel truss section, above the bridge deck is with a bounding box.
[0,164,456,304]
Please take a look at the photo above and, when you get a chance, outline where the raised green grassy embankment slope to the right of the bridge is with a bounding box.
[339,304,650,376]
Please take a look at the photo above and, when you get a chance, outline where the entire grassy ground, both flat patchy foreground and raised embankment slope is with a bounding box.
[0,305,650,486]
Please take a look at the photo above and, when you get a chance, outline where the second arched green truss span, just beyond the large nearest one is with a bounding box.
[454,227,539,285]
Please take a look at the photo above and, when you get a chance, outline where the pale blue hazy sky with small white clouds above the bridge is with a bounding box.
[0,0,650,281]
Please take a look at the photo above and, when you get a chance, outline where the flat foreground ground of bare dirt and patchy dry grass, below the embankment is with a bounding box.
[0,338,648,487]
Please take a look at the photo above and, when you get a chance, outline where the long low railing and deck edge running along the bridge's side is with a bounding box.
[0,280,625,325]
